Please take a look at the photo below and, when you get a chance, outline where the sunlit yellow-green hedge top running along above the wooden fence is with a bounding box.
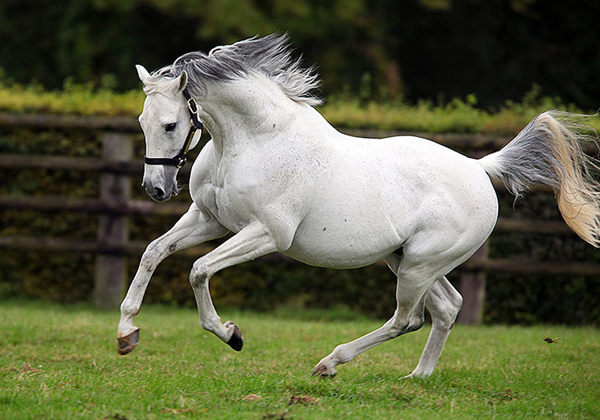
[0,80,600,134]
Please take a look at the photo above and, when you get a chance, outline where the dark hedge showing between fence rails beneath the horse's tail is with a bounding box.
[484,193,600,325]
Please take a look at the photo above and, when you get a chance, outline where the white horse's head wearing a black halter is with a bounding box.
[136,66,202,201]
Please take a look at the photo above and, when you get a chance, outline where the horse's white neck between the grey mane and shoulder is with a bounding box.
[202,77,335,153]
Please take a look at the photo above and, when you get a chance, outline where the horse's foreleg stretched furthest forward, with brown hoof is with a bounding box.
[117,204,228,354]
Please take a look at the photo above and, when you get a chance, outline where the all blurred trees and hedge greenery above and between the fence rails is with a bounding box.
[0,0,600,324]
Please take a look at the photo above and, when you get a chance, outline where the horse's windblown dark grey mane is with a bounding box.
[152,34,321,106]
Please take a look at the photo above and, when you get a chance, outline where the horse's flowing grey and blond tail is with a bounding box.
[479,111,600,248]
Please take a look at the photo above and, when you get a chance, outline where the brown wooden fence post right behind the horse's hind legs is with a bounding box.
[457,241,488,325]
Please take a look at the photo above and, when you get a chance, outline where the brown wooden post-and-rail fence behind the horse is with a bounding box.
[0,113,600,324]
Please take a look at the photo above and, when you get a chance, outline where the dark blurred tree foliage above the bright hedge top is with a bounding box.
[0,0,600,110]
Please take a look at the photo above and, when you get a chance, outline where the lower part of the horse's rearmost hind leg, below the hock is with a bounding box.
[407,277,462,378]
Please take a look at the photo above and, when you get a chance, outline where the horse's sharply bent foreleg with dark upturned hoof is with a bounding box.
[190,222,277,351]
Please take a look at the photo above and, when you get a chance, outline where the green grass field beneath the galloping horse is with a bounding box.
[0,301,600,420]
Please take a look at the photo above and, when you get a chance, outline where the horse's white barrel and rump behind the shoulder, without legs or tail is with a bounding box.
[286,138,498,275]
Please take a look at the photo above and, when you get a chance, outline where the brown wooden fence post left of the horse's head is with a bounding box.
[94,132,133,310]
